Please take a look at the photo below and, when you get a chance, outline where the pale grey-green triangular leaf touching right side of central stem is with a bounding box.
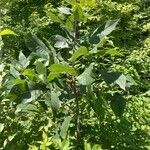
[77,64,94,85]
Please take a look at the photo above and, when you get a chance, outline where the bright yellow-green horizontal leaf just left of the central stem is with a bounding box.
[49,64,77,76]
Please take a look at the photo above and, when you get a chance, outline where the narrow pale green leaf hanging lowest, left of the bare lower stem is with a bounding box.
[60,116,71,139]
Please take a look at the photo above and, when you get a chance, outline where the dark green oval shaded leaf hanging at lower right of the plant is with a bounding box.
[109,94,126,117]
